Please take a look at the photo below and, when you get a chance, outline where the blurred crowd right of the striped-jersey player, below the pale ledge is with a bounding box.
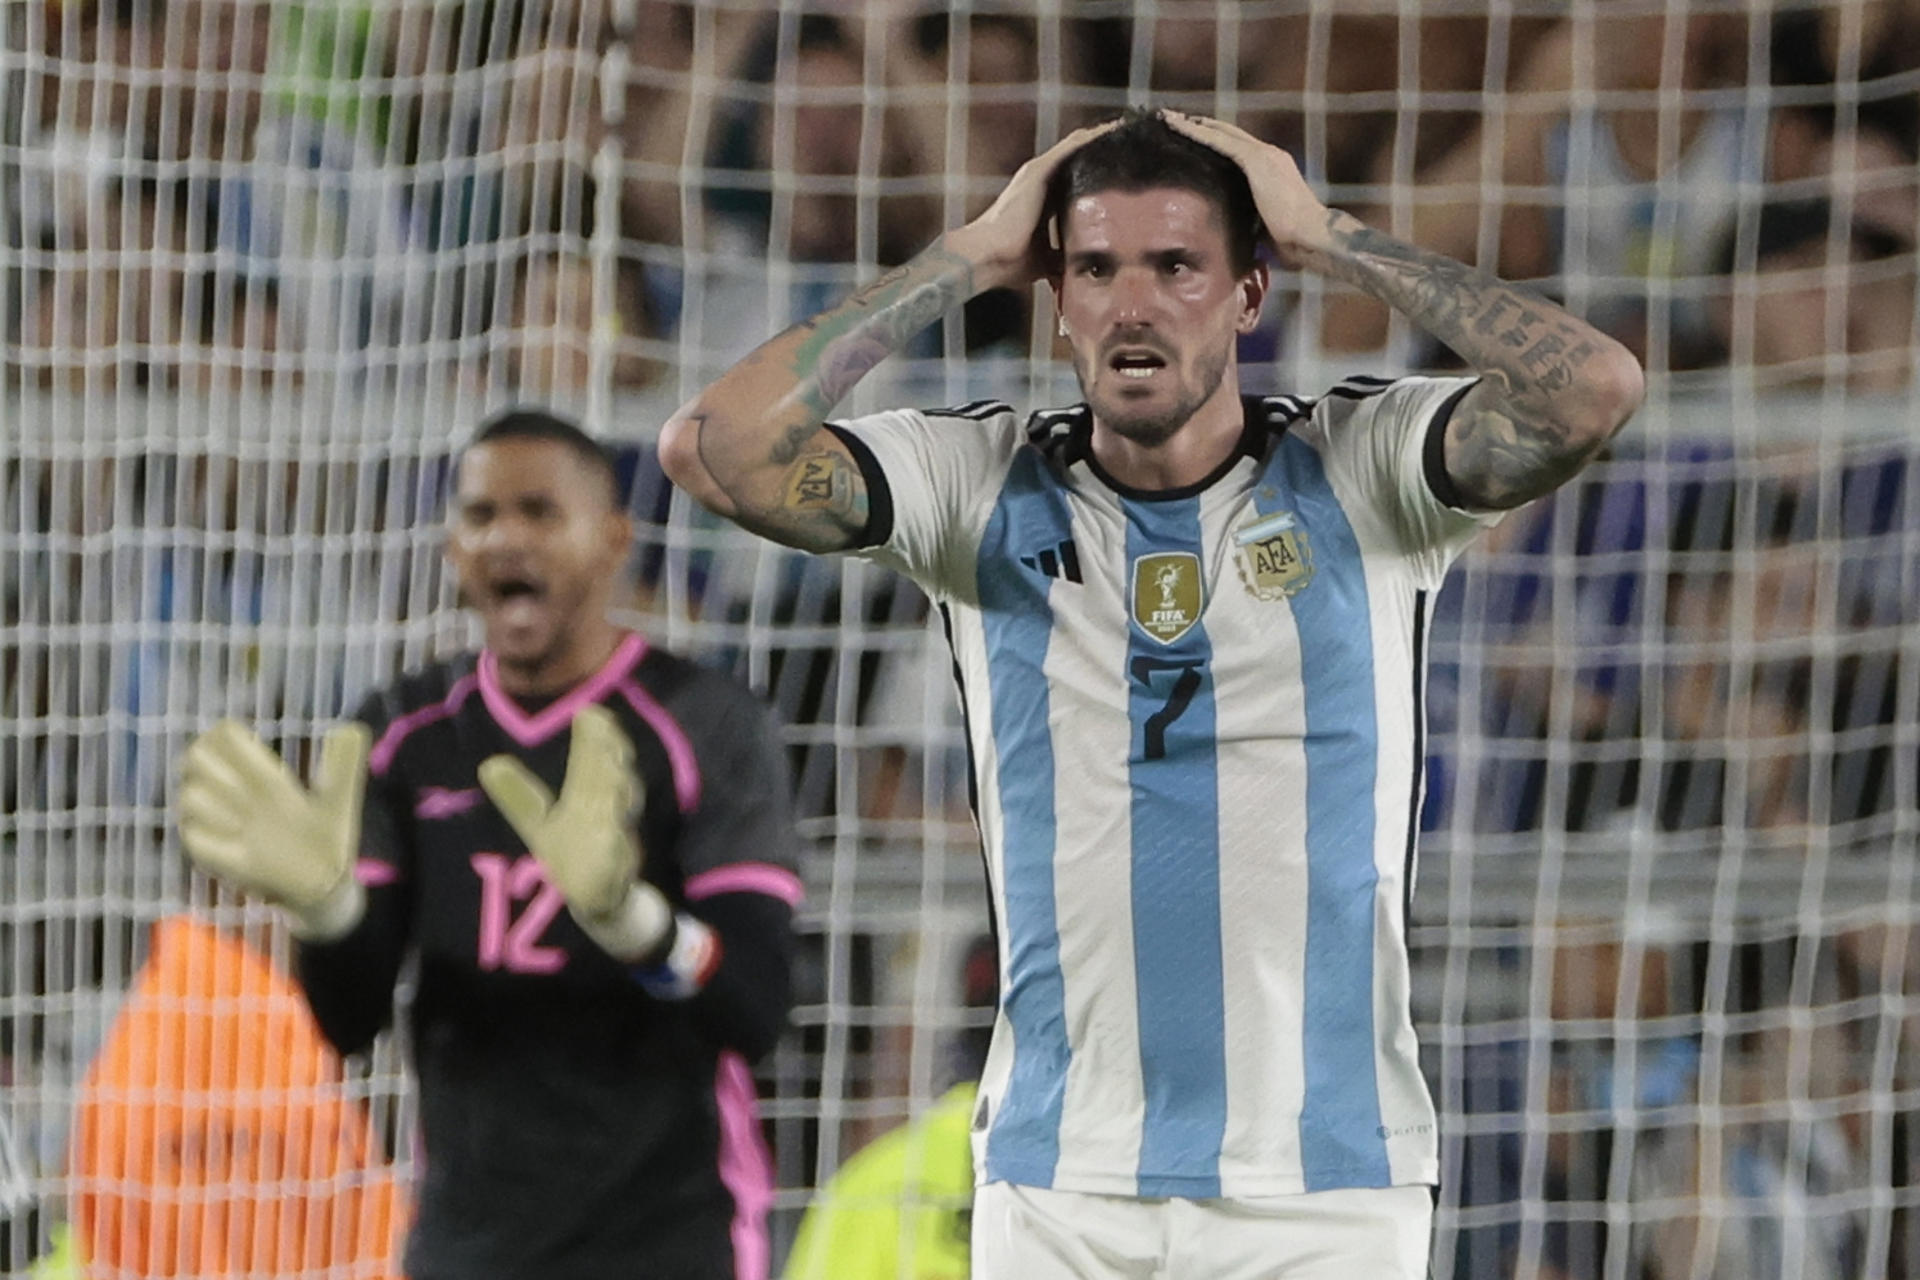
[1428,462,1920,1280]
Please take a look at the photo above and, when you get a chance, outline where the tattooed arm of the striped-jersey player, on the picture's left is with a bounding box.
[660,127,1106,551]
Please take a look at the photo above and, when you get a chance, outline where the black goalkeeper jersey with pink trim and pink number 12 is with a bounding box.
[298,635,801,1280]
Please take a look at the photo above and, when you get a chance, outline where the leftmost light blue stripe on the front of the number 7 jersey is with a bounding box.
[977,449,1079,1188]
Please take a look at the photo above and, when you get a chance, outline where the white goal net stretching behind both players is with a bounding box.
[0,0,1920,1280]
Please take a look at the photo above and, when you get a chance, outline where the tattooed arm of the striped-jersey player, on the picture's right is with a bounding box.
[1169,113,1645,509]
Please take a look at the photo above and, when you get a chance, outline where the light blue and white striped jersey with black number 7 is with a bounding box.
[835,378,1494,1197]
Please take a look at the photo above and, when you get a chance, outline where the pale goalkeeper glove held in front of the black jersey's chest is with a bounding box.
[480,706,674,963]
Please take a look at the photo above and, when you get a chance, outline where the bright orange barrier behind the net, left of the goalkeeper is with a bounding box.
[73,915,405,1280]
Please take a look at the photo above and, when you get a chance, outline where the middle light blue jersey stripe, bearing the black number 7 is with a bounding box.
[1121,499,1227,1199]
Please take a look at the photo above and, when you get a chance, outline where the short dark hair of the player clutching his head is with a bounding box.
[1046,107,1265,274]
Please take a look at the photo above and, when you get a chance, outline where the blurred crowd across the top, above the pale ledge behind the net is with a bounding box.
[0,0,1920,393]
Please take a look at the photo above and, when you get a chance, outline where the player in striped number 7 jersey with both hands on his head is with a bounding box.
[660,111,1642,1280]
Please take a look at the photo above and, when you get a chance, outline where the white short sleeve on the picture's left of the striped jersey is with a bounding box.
[829,403,1021,599]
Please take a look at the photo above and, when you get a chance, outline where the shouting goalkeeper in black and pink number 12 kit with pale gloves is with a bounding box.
[180,411,801,1280]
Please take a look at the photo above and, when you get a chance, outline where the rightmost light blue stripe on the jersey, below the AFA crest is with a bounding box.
[1256,436,1392,1192]
